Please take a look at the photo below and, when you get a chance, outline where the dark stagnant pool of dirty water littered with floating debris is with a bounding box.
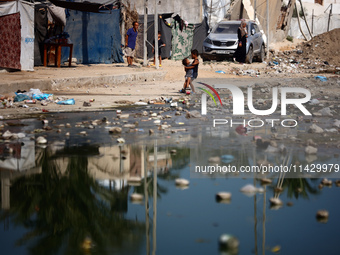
[0,108,340,255]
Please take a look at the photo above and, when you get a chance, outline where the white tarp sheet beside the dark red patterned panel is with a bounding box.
[0,0,34,71]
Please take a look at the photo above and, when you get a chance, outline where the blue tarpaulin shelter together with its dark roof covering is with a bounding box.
[51,0,124,64]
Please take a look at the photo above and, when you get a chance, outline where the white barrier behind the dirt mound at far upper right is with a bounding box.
[288,13,340,40]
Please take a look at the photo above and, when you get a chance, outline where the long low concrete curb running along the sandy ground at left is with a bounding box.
[0,71,166,94]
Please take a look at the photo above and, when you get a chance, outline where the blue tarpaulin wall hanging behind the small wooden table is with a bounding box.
[62,9,124,64]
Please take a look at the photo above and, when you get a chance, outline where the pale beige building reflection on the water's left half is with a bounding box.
[0,139,172,209]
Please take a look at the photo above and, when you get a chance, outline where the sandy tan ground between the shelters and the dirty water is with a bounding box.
[0,38,340,119]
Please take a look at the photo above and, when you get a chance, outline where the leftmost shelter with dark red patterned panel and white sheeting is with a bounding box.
[0,0,34,71]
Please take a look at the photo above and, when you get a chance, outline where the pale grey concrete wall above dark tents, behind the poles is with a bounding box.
[127,0,203,23]
